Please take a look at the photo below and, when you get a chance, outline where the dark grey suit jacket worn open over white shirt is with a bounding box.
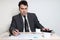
[10,13,43,32]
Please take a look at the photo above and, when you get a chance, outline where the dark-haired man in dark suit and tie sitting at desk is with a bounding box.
[10,1,48,32]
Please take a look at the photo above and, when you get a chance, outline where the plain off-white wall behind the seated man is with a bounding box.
[0,0,60,35]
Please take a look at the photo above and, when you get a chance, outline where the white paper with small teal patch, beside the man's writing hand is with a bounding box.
[10,33,42,39]
